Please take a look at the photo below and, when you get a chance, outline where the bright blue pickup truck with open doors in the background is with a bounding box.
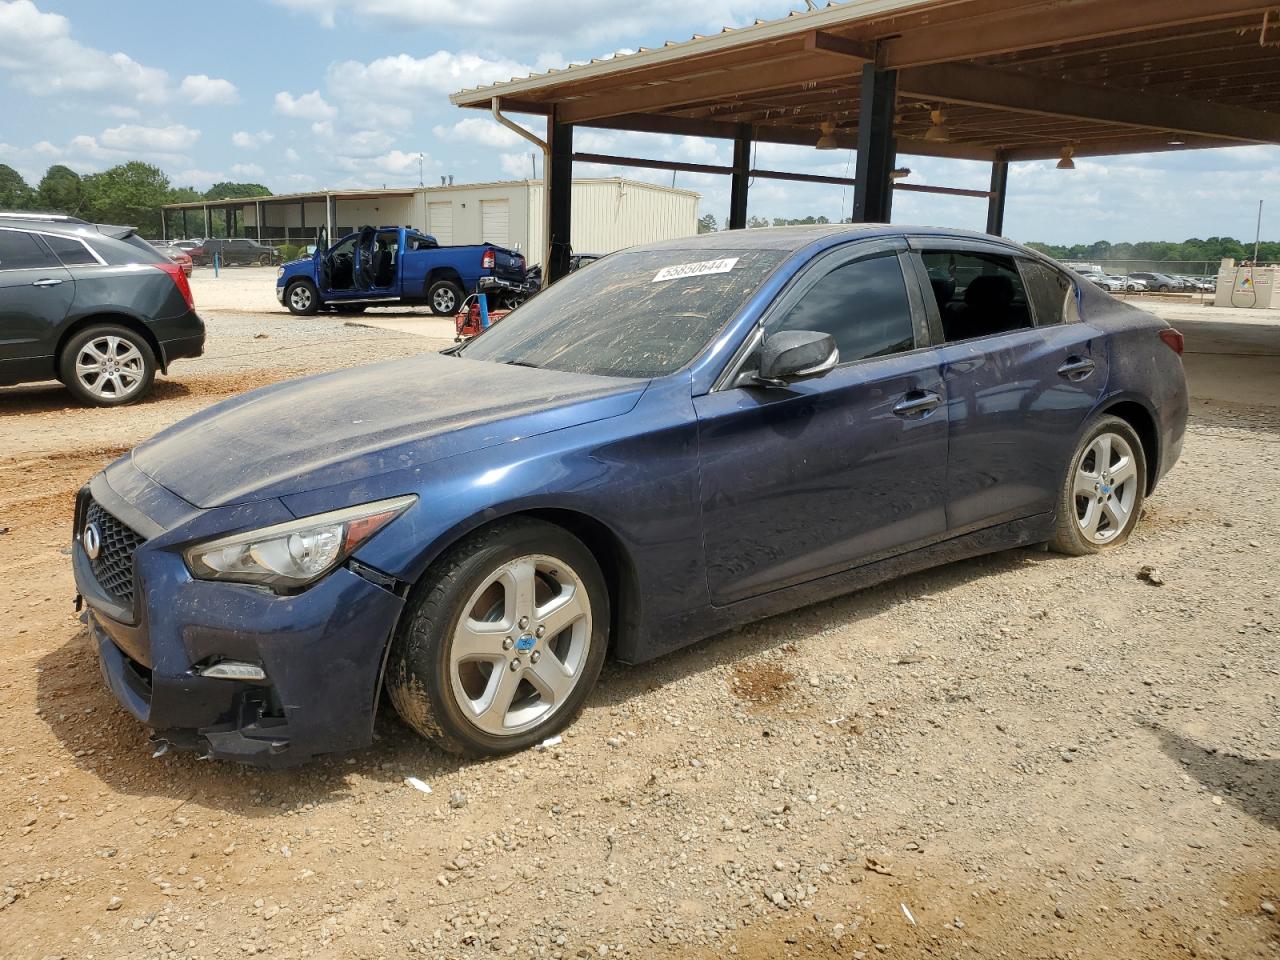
[275,227,532,316]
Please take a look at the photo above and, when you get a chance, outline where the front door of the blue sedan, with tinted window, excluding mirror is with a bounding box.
[694,242,947,604]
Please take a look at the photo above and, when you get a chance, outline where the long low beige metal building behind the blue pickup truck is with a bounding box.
[164,178,700,266]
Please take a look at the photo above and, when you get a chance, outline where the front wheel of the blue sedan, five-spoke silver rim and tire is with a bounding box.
[387,518,609,756]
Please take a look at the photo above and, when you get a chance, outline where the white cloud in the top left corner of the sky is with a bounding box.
[0,0,234,104]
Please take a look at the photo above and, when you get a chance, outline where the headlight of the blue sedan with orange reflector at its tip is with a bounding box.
[183,495,417,590]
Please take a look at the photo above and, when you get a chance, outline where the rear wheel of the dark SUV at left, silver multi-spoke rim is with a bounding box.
[58,324,156,407]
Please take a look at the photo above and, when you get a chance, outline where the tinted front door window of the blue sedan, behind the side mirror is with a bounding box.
[768,252,915,364]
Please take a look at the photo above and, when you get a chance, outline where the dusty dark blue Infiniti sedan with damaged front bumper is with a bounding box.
[73,225,1187,764]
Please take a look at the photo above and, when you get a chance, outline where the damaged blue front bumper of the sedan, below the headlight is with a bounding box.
[72,461,403,765]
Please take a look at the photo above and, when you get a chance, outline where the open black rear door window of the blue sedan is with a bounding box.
[922,248,1032,343]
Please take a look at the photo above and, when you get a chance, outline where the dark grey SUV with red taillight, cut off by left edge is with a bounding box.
[0,211,205,407]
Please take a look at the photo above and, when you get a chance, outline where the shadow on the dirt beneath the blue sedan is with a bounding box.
[36,549,1049,817]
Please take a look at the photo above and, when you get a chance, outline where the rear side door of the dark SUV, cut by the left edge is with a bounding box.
[0,228,76,383]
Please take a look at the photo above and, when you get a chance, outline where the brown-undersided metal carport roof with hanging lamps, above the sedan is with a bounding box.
[452,0,1280,160]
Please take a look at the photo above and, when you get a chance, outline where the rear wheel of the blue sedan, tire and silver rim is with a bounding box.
[1050,416,1147,557]
